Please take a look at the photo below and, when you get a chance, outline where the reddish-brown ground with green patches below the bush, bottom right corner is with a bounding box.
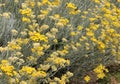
[69,63,120,84]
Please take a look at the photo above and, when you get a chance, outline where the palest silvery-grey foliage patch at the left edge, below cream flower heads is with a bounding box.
[0,15,16,46]
